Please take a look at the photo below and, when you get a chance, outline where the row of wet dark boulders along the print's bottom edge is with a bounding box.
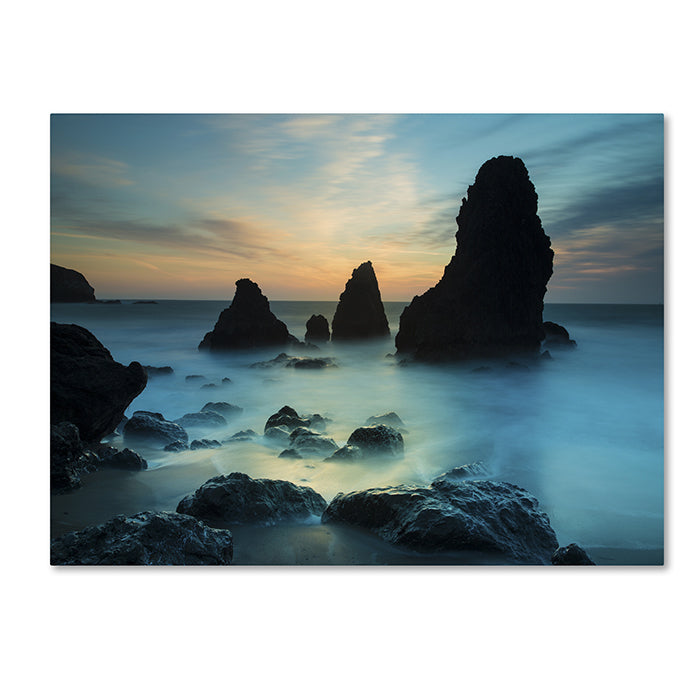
[51,464,593,565]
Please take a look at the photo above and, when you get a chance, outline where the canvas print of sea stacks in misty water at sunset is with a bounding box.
[50,114,664,566]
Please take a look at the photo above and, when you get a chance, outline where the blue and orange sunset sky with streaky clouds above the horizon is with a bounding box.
[51,114,664,303]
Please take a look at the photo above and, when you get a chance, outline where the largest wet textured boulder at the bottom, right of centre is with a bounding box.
[322,480,558,564]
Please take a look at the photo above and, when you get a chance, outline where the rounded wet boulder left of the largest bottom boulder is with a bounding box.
[177,472,327,525]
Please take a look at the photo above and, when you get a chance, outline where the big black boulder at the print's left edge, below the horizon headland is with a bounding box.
[51,323,148,442]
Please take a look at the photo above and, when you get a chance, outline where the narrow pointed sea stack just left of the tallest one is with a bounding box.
[331,261,389,340]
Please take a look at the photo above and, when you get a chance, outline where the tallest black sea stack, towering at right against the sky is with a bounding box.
[396,156,554,360]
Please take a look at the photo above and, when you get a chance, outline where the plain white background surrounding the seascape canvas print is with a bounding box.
[0,0,699,700]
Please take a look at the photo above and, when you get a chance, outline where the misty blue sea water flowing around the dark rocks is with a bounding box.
[51,301,664,564]
